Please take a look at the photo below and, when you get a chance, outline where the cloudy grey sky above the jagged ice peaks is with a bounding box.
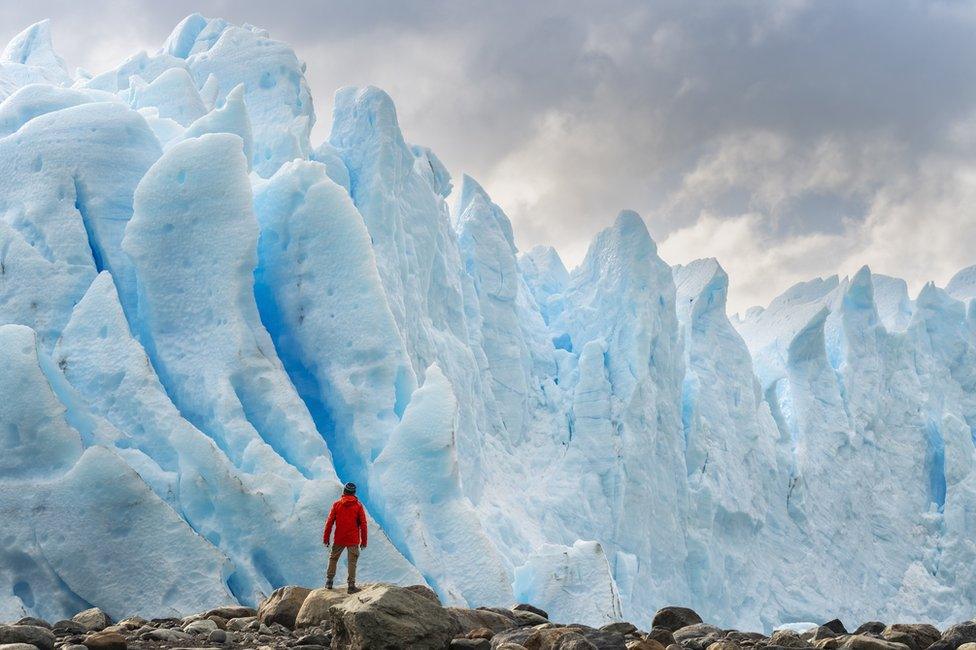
[0,0,976,312]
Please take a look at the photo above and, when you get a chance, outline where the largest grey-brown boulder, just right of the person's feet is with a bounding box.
[329,584,461,650]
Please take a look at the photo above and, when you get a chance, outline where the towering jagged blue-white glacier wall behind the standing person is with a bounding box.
[0,14,976,630]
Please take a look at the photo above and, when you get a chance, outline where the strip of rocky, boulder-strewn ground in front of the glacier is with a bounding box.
[0,584,976,650]
